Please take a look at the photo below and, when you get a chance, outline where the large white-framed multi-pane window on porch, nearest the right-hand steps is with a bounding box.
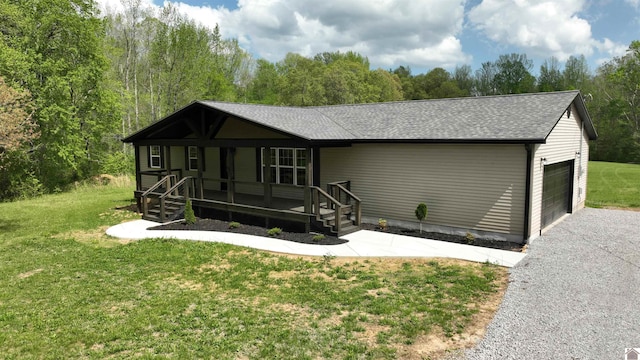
[260,148,307,185]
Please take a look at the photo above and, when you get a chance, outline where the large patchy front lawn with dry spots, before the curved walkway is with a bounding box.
[0,176,507,359]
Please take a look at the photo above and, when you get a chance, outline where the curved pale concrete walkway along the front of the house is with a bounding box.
[107,220,526,267]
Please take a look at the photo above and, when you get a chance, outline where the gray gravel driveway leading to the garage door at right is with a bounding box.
[466,208,640,360]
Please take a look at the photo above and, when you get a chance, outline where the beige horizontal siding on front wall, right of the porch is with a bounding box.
[320,144,526,236]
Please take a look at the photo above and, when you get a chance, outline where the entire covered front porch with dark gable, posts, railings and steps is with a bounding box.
[125,103,361,234]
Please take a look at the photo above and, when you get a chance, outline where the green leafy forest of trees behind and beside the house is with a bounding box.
[0,0,640,201]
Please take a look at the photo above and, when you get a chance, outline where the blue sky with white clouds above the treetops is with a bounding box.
[99,0,640,74]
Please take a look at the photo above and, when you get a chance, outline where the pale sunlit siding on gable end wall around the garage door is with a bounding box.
[531,105,589,237]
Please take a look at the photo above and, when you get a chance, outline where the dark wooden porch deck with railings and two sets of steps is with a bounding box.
[135,169,362,235]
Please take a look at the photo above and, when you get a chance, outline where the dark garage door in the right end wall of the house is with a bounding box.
[542,160,573,228]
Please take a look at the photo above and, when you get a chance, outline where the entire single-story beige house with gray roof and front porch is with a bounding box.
[123,91,597,242]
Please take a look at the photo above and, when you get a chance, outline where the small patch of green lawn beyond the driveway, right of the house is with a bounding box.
[586,161,640,208]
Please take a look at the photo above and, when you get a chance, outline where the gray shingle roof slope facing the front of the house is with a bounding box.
[200,91,595,141]
